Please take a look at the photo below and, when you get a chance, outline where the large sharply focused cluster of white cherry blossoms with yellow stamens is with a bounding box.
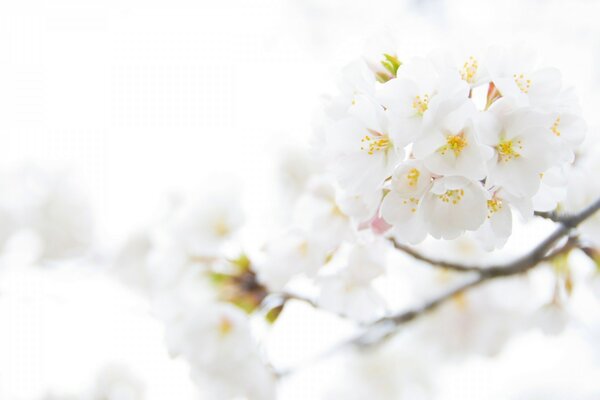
[317,48,586,249]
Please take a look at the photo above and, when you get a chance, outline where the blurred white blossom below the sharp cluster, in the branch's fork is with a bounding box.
[317,243,386,322]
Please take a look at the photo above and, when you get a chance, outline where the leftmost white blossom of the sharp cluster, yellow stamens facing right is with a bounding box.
[327,96,403,194]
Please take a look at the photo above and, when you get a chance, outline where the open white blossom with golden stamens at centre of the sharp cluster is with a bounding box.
[413,102,492,180]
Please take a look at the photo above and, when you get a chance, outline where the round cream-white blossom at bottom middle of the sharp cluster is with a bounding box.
[421,177,487,239]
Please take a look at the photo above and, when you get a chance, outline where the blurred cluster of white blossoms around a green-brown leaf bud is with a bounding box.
[117,188,274,400]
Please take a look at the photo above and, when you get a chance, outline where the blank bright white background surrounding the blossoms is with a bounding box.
[0,0,600,400]
